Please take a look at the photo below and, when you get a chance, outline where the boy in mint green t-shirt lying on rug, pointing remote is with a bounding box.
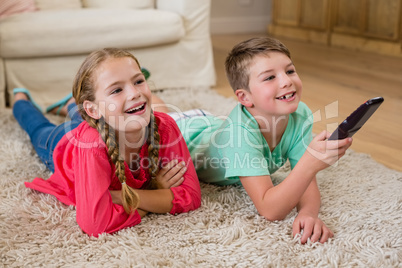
[173,37,352,243]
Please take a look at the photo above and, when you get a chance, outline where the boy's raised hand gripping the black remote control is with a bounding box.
[306,130,353,172]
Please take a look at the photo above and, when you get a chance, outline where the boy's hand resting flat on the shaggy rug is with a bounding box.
[293,213,334,244]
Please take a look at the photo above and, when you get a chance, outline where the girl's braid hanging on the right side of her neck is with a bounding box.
[147,111,160,189]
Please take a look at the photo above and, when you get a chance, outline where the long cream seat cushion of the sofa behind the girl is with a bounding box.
[0,8,185,58]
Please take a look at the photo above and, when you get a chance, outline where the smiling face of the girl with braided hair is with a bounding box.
[86,57,151,135]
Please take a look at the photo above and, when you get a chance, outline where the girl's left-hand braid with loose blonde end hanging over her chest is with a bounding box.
[96,118,140,213]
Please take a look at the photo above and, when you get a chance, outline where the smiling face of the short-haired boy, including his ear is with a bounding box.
[236,52,302,117]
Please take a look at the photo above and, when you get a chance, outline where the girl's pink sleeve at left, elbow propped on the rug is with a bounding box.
[74,149,141,237]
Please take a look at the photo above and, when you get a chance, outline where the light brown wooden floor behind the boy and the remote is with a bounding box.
[212,34,402,171]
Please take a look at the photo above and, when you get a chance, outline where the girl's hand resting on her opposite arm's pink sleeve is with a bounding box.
[155,159,187,189]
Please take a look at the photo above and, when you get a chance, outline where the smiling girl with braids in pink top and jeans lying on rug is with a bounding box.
[13,49,201,237]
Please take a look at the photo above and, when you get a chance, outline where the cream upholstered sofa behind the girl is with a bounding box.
[0,0,215,108]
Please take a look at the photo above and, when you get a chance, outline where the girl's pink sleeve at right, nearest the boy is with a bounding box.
[159,117,201,214]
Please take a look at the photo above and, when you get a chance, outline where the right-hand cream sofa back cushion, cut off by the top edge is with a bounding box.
[82,0,155,8]
